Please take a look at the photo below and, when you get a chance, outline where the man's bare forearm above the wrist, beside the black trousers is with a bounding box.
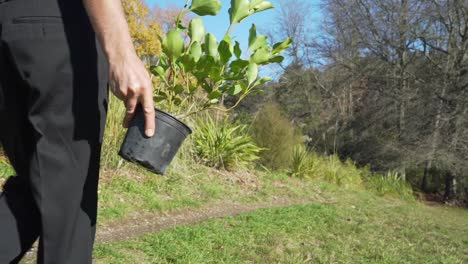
[83,0,135,61]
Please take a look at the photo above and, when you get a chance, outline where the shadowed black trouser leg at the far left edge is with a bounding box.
[0,32,40,263]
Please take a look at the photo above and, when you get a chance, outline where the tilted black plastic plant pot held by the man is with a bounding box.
[119,107,192,175]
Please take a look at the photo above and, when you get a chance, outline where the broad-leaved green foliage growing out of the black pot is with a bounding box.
[150,0,291,117]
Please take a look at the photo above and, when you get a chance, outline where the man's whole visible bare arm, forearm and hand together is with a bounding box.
[83,0,156,137]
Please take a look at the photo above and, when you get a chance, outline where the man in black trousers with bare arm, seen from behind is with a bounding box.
[0,0,155,264]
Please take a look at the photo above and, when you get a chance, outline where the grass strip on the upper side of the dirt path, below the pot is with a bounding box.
[99,158,319,225]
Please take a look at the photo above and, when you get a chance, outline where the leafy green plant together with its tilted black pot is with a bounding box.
[119,0,291,174]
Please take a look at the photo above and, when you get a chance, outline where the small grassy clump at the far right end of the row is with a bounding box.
[365,171,414,200]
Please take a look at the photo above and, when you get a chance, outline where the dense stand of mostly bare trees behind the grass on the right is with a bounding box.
[233,0,468,204]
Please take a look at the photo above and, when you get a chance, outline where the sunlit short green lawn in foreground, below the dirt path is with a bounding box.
[95,187,468,263]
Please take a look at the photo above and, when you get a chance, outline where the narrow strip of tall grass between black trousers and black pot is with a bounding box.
[101,95,126,169]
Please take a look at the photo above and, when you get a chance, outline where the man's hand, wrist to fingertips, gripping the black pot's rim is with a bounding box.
[109,54,155,137]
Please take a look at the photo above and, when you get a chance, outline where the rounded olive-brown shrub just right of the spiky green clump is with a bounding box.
[251,102,303,170]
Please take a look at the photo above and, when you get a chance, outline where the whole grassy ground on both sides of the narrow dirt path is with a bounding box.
[0,101,468,263]
